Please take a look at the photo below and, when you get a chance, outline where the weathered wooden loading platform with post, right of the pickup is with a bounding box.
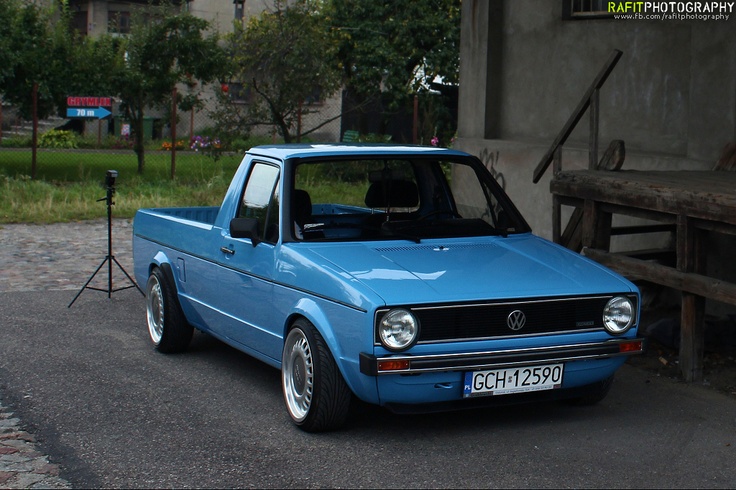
[550,170,736,381]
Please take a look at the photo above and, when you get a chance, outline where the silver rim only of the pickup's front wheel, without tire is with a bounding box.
[281,328,314,422]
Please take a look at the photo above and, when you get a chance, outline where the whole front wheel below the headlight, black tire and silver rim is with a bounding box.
[281,318,352,432]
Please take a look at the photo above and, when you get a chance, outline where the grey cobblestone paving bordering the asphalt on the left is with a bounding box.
[0,219,133,489]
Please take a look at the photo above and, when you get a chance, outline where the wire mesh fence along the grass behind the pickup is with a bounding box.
[0,85,456,180]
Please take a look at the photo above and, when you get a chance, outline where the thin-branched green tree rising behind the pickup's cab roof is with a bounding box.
[227,0,341,143]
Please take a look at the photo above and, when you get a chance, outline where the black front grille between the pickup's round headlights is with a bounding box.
[376,295,633,343]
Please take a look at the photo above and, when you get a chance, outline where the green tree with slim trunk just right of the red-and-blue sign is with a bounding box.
[106,4,227,174]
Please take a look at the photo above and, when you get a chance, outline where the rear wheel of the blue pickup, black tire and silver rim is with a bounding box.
[146,267,194,354]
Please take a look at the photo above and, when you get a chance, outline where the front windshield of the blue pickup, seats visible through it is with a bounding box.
[291,158,529,242]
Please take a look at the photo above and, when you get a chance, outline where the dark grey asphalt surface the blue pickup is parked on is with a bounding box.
[0,290,736,488]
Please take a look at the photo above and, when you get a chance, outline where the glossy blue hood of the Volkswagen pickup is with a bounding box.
[302,234,635,304]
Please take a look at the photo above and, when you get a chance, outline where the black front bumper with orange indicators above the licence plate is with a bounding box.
[360,338,645,376]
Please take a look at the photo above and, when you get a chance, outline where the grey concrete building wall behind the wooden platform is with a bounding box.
[455,0,736,318]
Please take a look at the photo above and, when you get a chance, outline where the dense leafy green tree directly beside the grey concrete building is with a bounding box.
[324,0,460,138]
